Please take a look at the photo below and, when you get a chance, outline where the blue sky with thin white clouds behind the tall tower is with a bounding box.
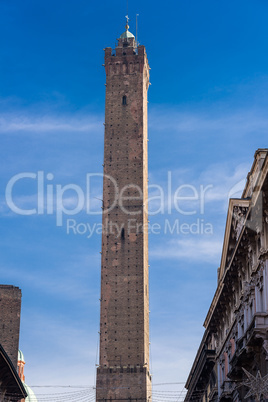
[0,0,268,398]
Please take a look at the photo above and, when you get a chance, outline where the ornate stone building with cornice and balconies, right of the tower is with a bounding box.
[185,149,268,402]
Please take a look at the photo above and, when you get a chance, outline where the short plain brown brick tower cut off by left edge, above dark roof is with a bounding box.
[0,285,21,367]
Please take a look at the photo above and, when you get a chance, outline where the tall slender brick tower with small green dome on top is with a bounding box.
[96,19,151,402]
